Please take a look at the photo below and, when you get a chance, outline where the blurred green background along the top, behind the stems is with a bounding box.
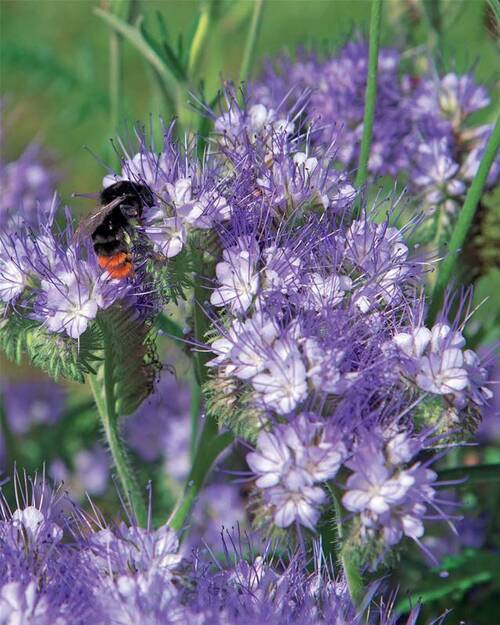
[0,0,498,205]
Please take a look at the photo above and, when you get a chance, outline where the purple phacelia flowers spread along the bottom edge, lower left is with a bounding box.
[0,476,446,625]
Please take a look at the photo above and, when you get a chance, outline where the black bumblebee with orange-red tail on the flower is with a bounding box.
[75,180,154,280]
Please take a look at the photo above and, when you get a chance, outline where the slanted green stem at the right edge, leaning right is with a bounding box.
[428,115,500,324]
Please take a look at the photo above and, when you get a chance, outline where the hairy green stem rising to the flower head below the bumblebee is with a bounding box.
[89,331,148,527]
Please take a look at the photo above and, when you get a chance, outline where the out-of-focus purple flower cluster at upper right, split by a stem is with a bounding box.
[248,41,500,245]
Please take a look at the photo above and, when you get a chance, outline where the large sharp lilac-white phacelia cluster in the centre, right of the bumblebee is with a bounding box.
[176,89,490,546]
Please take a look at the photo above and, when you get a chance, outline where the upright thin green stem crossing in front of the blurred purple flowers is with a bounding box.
[356,0,382,196]
